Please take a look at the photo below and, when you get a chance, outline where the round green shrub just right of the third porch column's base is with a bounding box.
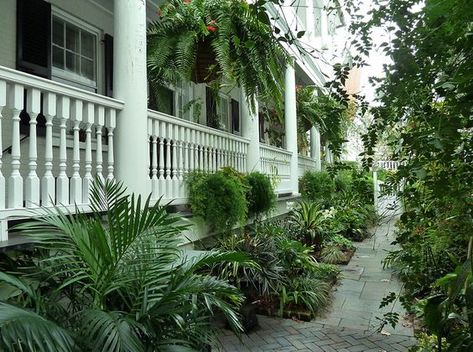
[299,171,335,205]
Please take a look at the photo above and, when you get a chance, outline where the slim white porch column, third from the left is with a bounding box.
[284,64,299,194]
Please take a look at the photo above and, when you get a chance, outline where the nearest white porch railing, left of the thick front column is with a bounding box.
[0,67,123,209]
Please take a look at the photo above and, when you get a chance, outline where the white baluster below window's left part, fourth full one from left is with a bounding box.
[56,97,71,205]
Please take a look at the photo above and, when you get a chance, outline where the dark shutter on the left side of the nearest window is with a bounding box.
[16,0,51,78]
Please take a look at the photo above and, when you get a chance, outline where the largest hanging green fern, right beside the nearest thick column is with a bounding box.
[148,0,288,111]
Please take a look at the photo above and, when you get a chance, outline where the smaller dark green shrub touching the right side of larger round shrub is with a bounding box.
[246,172,276,215]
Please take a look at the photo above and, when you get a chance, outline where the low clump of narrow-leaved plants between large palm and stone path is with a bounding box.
[213,222,340,317]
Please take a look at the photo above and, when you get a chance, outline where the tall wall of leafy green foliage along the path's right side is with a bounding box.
[342,0,473,351]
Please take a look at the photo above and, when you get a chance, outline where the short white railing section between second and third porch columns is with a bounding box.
[260,144,292,193]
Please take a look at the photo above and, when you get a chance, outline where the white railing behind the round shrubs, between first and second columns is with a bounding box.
[148,110,249,202]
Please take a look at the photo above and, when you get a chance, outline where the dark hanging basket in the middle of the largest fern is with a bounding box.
[192,36,220,83]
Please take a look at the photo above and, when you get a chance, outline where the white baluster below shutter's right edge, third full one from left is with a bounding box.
[41,93,56,207]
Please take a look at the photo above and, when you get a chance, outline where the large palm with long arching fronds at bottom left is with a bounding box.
[0,181,242,351]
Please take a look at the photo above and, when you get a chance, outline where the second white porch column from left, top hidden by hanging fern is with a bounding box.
[240,88,261,172]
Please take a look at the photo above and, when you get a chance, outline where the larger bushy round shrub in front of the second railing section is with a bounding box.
[186,168,248,232]
